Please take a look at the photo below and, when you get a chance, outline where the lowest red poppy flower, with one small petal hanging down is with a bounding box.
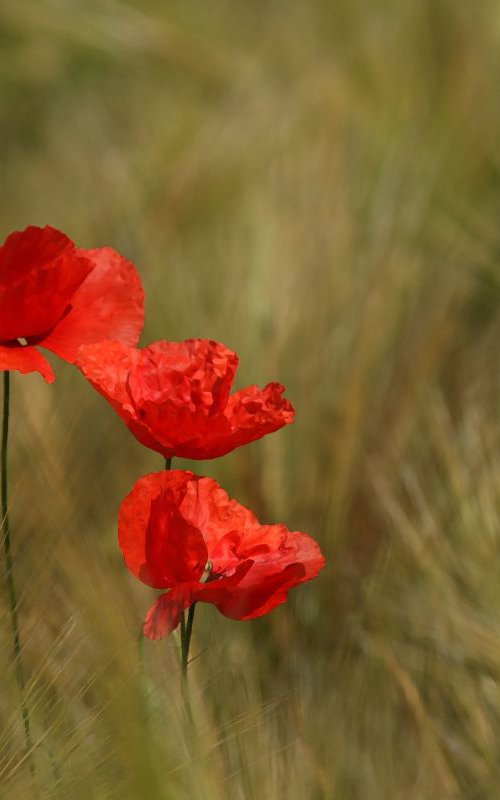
[118,470,325,639]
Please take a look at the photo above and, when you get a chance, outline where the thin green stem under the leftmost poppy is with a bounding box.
[0,370,35,775]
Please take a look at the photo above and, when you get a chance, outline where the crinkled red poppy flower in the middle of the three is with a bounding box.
[77,339,294,458]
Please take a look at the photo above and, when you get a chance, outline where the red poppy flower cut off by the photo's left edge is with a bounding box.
[0,226,144,383]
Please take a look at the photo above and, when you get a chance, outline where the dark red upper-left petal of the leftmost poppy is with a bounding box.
[0,225,95,342]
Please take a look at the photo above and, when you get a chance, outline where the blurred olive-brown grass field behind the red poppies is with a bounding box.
[0,0,500,800]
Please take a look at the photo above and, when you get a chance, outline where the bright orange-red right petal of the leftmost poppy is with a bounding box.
[40,247,144,363]
